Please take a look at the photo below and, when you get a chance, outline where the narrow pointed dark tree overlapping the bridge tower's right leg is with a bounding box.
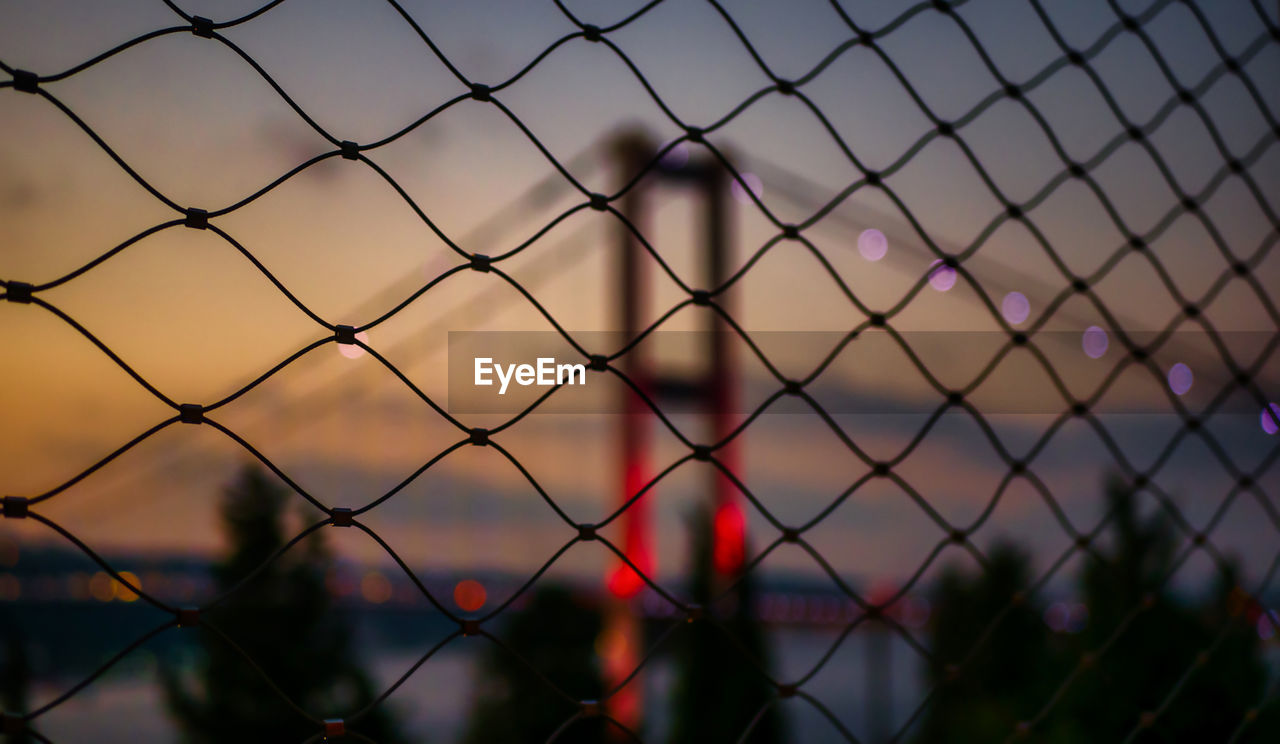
[671,510,783,744]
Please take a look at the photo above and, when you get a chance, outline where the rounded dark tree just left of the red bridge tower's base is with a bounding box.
[463,585,608,744]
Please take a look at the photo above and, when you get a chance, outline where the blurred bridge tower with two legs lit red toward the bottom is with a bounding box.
[604,131,746,727]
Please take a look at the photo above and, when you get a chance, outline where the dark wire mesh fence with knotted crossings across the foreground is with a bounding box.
[0,0,1280,741]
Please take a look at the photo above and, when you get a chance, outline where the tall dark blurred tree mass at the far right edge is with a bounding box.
[1068,480,1280,744]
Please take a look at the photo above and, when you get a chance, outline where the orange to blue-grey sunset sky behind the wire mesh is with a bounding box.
[0,0,1280,596]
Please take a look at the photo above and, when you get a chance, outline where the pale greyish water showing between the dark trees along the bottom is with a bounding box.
[32,627,923,744]
